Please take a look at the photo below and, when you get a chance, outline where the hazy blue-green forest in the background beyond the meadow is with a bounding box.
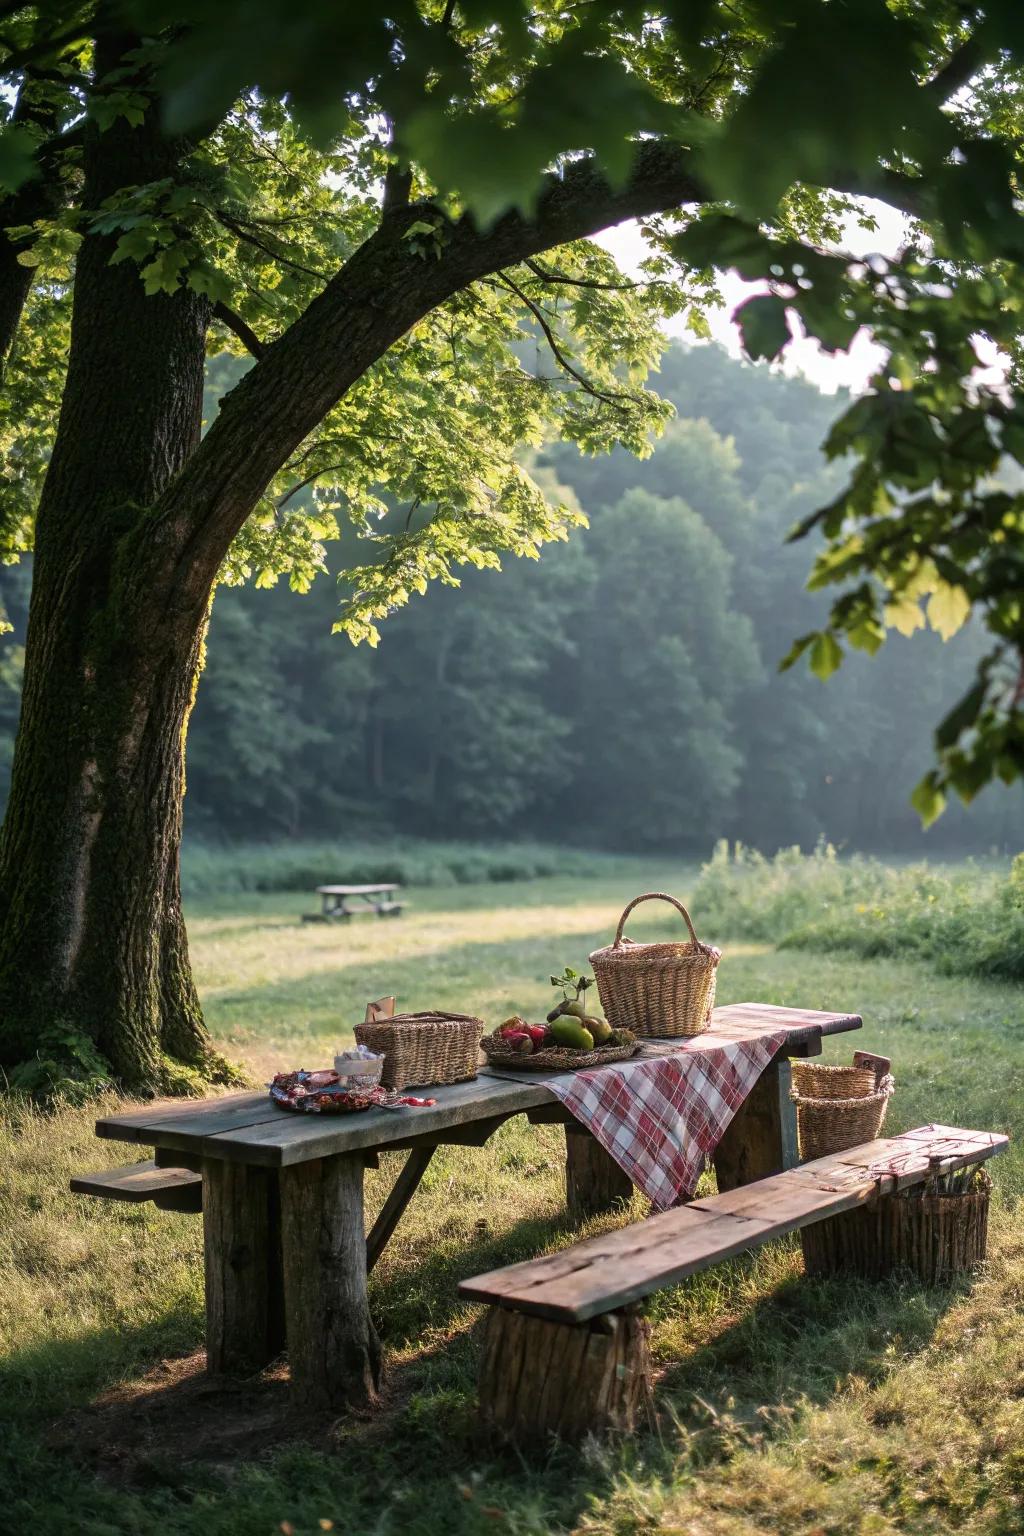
[0,344,1024,854]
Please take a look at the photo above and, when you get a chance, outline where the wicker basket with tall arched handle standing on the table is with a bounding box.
[590,891,722,1038]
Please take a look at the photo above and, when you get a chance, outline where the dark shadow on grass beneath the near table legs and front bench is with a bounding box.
[0,1215,976,1536]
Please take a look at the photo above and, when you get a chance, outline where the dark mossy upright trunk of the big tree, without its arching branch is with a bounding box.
[0,38,222,1089]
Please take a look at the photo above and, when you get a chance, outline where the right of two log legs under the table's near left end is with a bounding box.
[279,1154,381,1409]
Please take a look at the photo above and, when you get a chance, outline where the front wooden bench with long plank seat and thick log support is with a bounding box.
[459,1126,1007,1445]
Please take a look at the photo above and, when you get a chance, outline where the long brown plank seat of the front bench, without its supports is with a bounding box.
[459,1126,1007,1322]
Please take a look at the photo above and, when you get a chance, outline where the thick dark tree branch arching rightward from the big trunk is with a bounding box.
[154,140,939,608]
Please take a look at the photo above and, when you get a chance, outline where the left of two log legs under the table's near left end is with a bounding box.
[203,1158,284,1375]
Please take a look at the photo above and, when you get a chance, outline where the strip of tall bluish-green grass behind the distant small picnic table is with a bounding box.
[181,837,626,897]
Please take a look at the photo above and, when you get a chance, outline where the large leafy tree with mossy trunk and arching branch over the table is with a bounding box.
[0,0,1024,1089]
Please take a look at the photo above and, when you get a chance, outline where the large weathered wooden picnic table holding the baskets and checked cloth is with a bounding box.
[97,1003,861,1407]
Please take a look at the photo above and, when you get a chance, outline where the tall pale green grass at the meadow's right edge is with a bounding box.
[694,842,1024,980]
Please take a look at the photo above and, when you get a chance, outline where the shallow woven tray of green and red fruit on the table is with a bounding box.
[481,968,640,1072]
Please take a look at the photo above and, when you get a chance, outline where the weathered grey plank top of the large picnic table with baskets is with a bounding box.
[97,1003,861,1167]
